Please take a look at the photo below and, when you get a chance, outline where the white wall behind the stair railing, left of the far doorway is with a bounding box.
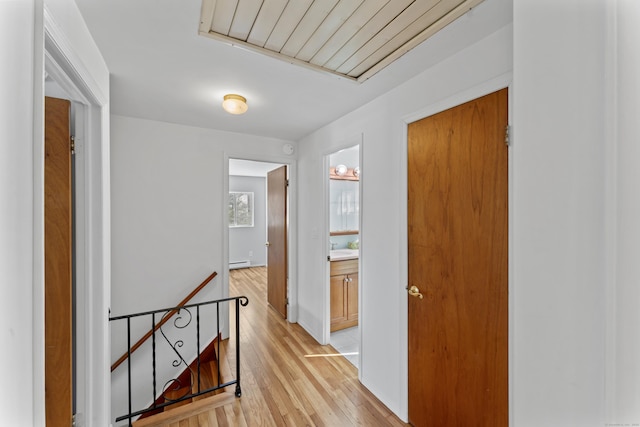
[111,115,294,424]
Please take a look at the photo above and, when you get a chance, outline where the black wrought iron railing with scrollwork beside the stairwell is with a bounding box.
[109,296,249,426]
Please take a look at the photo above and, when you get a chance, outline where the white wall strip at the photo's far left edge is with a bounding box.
[0,1,37,425]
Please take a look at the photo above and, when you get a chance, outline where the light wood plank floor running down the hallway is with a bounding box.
[137,267,408,427]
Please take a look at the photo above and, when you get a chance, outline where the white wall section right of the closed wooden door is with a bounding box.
[511,0,612,426]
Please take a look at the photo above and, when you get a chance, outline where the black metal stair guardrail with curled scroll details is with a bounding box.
[109,296,249,426]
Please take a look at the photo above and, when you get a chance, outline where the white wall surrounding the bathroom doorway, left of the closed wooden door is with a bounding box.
[298,18,512,419]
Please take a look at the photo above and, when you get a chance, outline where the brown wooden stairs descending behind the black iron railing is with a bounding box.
[133,337,236,427]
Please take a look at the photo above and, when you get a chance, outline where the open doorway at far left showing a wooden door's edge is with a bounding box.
[44,76,85,424]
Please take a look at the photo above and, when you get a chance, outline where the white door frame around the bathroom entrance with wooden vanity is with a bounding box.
[321,133,366,352]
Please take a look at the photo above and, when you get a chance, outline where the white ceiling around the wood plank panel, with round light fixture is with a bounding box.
[76,0,512,141]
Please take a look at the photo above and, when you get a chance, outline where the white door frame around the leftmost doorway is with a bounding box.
[33,8,111,425]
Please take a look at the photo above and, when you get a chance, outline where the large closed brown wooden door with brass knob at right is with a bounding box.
[408,89,509,427]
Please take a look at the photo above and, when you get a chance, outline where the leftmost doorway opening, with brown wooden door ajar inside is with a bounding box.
[44,71,97,424]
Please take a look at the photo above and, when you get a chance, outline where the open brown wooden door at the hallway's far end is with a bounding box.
[267,165,287,319]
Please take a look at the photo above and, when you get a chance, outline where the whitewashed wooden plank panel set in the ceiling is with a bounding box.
[199,0,482,82]
